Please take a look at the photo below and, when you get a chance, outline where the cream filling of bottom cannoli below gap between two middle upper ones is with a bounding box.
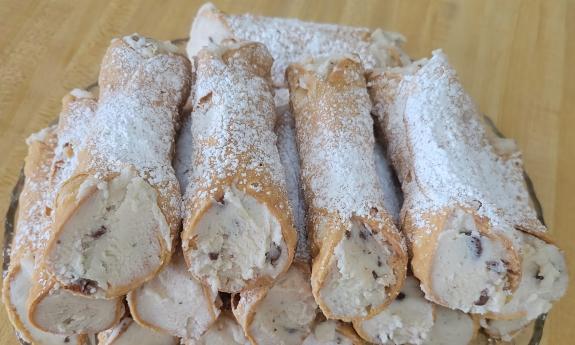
[250,266,317,345]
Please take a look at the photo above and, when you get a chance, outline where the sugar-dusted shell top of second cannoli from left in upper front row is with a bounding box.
[186,43,289,215]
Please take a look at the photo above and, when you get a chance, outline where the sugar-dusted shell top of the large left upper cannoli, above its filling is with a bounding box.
[86,35,190,222]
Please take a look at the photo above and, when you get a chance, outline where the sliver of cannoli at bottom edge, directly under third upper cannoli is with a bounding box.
[302,320,366,345]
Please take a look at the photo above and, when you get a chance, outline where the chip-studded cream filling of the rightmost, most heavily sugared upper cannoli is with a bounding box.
[431,210,509,313]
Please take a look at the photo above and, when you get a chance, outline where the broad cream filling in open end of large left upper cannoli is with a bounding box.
[49,169,172,293]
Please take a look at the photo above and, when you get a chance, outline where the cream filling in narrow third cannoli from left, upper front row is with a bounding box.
[320,221,396,317]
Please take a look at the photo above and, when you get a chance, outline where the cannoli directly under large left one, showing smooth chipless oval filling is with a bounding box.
[27,89,124,334]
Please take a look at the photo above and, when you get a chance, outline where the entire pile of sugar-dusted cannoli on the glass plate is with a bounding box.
[3,3,568,345]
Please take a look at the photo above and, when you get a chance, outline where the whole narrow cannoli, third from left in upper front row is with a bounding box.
[287,57,407,321]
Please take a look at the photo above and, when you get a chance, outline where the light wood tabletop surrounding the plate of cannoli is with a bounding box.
[0,0,575,345]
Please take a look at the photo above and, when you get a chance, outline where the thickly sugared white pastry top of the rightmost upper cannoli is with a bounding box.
[370,50,545,238]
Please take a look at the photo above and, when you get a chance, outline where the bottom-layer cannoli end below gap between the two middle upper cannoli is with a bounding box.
[232,262,317,345]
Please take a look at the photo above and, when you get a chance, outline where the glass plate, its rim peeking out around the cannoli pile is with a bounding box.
[2,38,547,345]
